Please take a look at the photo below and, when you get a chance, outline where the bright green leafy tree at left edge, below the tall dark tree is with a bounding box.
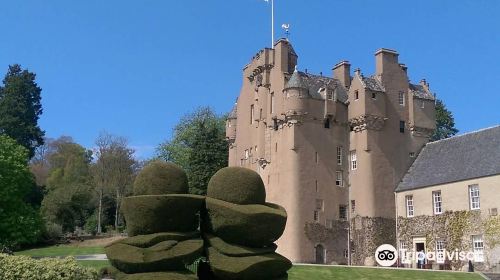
[0,135,42,247]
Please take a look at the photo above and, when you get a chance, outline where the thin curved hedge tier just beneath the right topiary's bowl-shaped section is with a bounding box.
[205,235,277,257]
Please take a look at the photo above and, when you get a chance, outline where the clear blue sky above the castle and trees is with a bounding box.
[0,0,500,157]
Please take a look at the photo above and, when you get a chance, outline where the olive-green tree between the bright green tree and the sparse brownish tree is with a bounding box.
[42,136,95,232]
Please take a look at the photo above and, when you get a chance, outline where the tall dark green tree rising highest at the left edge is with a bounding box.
[0,64,44,158]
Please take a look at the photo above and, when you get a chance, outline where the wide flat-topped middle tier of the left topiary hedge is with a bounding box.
[121,194,205,237]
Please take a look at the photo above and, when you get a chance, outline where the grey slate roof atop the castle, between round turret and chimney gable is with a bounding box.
[285,71,348,103]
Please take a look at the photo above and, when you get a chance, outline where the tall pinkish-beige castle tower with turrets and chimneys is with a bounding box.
[226,39,435,265]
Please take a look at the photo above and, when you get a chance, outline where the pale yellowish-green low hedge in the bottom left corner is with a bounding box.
[0,254,98,280]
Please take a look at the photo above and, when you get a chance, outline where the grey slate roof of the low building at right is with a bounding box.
[396,125,500,192]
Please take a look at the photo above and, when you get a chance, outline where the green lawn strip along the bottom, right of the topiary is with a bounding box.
[288,265,483,280]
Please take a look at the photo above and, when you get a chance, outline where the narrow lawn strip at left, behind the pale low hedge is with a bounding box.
[14,245,104,257]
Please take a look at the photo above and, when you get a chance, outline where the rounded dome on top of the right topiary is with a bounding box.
[207,167,266,204]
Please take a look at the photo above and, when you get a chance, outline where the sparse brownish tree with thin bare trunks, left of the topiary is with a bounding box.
[92,132,137,233]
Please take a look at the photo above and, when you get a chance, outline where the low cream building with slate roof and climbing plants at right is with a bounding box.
[396,126,500,272]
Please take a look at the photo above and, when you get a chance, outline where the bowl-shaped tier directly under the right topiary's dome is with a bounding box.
[205,197,287,248]
